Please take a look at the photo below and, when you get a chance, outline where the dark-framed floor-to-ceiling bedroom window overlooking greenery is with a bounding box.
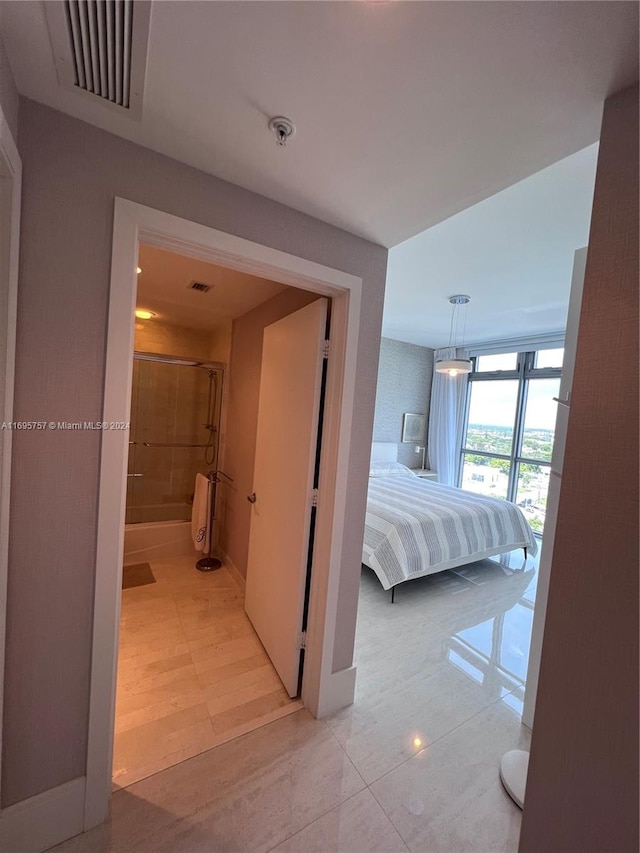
[459,349,564,533]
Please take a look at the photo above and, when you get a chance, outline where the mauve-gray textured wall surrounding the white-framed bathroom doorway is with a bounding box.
[2,100,387,806]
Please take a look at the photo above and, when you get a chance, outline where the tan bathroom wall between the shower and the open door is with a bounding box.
[218,287,318,577]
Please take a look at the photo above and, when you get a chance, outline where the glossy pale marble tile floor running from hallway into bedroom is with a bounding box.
[56,553,537,853]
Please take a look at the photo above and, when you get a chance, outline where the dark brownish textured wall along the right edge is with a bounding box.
[520,81,640,853]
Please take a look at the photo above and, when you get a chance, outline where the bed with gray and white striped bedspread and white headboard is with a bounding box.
[362,442,538,600]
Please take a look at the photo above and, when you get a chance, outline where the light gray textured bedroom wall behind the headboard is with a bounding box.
[373,338,433,468]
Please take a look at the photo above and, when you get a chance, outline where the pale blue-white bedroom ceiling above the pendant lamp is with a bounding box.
[382,144,598,347]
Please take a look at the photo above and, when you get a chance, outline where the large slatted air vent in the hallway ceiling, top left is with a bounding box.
[44,0,151,119]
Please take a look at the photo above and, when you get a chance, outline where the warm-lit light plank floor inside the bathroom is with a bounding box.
[113,558,302,788]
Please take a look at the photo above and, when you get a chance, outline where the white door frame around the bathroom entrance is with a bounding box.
[84,198,362,830]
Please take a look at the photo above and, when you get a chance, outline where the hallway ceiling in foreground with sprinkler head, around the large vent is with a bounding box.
[0,0,638,247]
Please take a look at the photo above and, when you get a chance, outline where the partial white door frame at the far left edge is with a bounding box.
[0,108,22,812]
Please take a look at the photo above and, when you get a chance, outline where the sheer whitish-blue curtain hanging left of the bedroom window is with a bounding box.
[429,347,467,486]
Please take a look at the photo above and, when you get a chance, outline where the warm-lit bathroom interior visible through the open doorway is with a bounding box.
[113,245,315,788]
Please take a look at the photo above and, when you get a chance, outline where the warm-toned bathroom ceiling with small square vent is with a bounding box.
[136,244,287,331]
